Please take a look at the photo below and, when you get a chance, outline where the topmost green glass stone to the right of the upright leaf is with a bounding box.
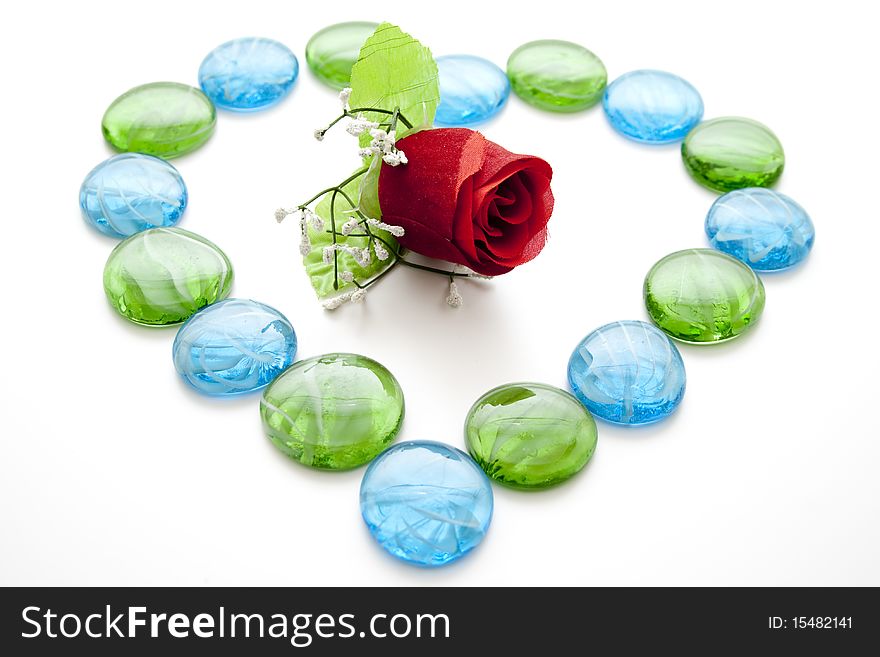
[507,40,608,112]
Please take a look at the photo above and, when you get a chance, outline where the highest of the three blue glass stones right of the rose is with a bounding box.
[602,70,703,144]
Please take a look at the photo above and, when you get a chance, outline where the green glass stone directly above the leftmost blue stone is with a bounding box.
[101,82,217,159]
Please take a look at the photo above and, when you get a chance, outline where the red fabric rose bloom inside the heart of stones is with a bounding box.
[379,128,553,276]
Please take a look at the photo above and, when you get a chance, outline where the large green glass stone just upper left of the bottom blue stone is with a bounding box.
[260,354,403,470]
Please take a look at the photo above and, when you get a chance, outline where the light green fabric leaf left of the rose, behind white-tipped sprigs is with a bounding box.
[303,170,398,299]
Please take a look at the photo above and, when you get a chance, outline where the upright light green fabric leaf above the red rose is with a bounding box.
[349,23,440,147]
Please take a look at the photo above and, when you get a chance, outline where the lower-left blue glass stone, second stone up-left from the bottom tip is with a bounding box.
[171,299,296,396]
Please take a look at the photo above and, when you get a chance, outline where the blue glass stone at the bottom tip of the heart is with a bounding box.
[361,441,493,566]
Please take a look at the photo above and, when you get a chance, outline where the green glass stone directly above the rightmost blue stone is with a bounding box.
[681,116,785,192]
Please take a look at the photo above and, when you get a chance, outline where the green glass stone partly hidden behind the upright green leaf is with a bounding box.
[306,22,379,89]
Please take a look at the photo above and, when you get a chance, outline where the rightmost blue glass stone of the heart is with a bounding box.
[706,187,816,271]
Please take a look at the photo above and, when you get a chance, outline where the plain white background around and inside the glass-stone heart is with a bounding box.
[0,0,880,585]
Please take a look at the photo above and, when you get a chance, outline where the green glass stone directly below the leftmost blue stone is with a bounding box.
[104,228,233,326]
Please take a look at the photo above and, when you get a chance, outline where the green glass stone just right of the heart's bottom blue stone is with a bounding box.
[465,383,597,488]
